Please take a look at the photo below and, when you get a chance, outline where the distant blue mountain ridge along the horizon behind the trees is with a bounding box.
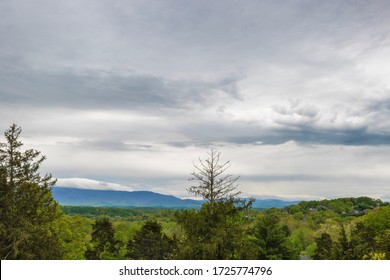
[52,187,297,208]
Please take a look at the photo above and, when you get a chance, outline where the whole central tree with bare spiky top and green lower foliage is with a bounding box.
[175,149,253,259]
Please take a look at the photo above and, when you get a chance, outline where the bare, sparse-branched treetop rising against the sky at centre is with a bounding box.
[188,149,241,204]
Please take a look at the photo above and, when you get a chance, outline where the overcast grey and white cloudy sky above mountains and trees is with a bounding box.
[0,0,390,200]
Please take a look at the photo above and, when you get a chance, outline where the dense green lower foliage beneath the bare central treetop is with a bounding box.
[175,199,254,260]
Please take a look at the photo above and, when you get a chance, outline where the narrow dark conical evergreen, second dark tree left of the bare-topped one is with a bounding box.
[85,218,121,260]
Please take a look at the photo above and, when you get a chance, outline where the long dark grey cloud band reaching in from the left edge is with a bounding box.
[0,63,239,109]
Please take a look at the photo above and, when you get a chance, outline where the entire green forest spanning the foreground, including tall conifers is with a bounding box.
[0,124,390,260]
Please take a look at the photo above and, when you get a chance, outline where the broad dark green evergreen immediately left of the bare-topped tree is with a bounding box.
[127,220,176,260]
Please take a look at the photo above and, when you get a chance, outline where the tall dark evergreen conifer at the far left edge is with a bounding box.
[0,124,62,259]
